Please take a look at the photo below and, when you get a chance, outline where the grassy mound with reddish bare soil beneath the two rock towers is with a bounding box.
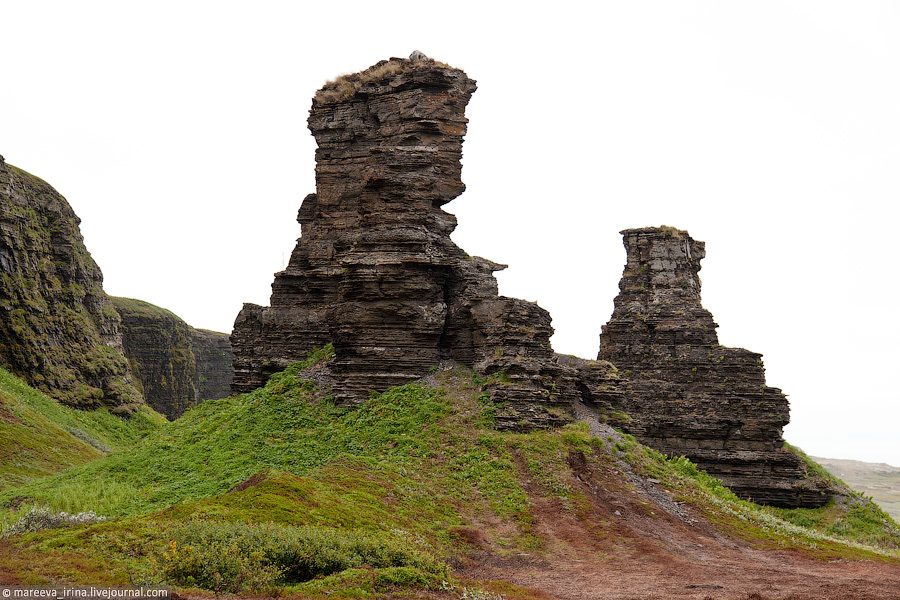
[0,353,900,599]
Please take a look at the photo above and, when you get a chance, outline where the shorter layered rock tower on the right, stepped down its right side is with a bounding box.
[598,227,830,507]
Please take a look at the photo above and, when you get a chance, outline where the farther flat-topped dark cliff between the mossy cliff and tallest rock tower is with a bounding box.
[112,298,233,419]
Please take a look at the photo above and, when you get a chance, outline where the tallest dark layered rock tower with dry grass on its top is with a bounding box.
[231,59,571,429]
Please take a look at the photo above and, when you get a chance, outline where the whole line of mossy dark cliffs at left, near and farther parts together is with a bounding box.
[0,157,234,419]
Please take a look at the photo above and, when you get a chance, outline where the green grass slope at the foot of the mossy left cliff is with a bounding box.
[0,368,164,490]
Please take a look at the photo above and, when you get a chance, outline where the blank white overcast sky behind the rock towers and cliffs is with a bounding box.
[0,0,900,465]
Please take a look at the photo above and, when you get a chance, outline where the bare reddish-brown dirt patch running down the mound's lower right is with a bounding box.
[460,455,900,600]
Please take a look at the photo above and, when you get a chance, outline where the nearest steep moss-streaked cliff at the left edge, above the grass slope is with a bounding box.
[0,157,143,412]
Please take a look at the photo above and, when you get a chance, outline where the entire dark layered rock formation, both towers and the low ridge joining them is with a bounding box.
[231,53,829,506]
